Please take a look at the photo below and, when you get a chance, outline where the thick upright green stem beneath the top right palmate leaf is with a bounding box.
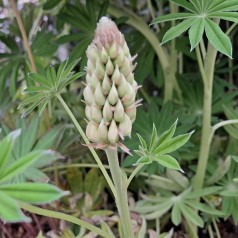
[194,44,217,190]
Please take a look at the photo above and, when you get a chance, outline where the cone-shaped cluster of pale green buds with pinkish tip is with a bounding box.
[83,17,140,151]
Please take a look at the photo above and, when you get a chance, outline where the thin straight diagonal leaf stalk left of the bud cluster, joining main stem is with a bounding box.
[56,94,116,196]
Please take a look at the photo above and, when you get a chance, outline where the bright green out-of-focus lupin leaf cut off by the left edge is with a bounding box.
[0,130,67,222]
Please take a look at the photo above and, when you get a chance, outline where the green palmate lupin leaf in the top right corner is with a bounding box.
[151,0,238,58]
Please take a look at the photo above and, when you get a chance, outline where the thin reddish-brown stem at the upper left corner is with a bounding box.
[10,0,37,73]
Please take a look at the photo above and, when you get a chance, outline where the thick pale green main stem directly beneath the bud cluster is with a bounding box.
[105,148,134,238]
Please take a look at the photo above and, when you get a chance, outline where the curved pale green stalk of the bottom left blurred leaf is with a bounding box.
[18,202,113,238]
